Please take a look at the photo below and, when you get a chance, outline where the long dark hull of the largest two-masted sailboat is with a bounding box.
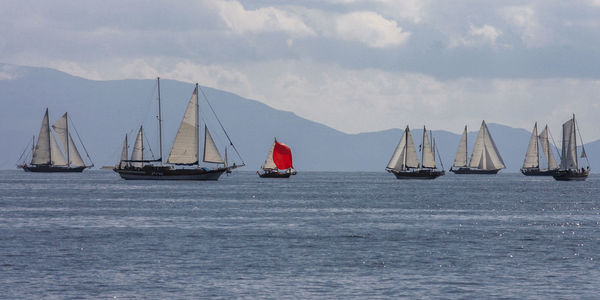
[113,166,229,181]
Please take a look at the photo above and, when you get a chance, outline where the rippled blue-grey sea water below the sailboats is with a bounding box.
[0,171,600,299]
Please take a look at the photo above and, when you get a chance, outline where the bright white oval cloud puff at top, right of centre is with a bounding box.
[335,12,410,48]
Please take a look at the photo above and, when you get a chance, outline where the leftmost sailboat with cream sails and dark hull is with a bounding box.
[18,108,94,173]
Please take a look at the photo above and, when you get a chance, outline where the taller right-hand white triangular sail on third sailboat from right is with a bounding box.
[469,121,506,170]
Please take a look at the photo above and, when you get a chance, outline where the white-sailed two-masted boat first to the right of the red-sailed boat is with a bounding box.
[386,126,445,179]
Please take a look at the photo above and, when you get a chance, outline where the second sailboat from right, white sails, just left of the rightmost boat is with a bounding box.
[521,122,558,176]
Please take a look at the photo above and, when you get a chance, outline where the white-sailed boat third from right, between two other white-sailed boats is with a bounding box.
[450,121,506,174]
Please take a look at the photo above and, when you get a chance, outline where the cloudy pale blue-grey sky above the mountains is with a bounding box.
[0,0,600,142]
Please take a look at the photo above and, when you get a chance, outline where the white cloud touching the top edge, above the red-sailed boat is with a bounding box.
[215,1,315,36]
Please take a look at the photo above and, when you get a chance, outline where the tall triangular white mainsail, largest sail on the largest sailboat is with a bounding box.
[167,86,199,164]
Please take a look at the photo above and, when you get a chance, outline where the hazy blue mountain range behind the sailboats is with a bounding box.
[0,64,600,172]
